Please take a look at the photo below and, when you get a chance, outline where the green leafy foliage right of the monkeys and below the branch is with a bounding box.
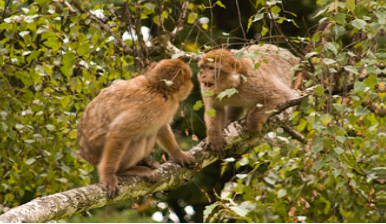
[204,0,386,222]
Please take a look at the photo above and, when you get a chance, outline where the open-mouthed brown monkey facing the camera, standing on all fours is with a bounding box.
[198,44,300,156]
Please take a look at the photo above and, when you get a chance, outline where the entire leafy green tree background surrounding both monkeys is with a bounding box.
[0,0,386,222]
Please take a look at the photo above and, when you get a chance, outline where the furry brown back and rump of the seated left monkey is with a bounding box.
[78,76,178,166]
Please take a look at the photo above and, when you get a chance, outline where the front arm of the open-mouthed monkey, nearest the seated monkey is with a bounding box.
[204,102,225,157]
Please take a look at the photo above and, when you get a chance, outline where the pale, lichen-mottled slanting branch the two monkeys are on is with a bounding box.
[0,93,308,223]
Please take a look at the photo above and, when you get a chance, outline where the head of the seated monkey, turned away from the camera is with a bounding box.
[146,58,193,101]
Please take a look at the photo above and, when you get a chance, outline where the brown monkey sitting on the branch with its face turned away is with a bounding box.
[77,59,195,198]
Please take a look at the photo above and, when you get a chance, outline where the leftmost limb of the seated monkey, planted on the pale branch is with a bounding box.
[98,131,130,198]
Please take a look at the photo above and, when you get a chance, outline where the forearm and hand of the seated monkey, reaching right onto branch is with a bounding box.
[156,125,195,166]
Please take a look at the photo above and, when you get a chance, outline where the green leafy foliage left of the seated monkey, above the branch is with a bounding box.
[0,0,133,208]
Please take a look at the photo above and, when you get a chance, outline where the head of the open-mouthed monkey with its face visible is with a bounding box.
[198,49,246,94]
